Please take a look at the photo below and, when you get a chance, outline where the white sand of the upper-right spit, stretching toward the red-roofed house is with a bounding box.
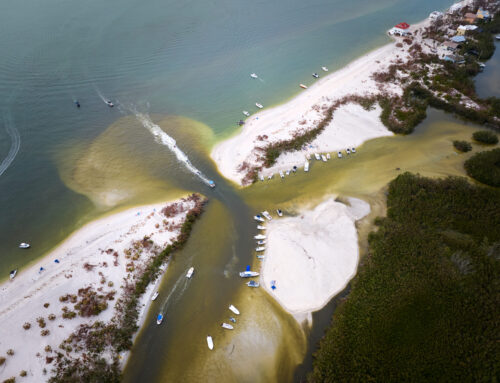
[211,19,440,184]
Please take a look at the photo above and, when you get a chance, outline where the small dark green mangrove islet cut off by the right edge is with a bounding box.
[464,148,500,188]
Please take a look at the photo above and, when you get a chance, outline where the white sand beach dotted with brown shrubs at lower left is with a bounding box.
[0,196,194,382]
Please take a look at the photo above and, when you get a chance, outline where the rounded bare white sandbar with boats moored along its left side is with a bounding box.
[261,198,370,317]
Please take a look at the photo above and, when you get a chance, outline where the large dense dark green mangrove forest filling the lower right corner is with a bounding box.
[309,173,500,382]
